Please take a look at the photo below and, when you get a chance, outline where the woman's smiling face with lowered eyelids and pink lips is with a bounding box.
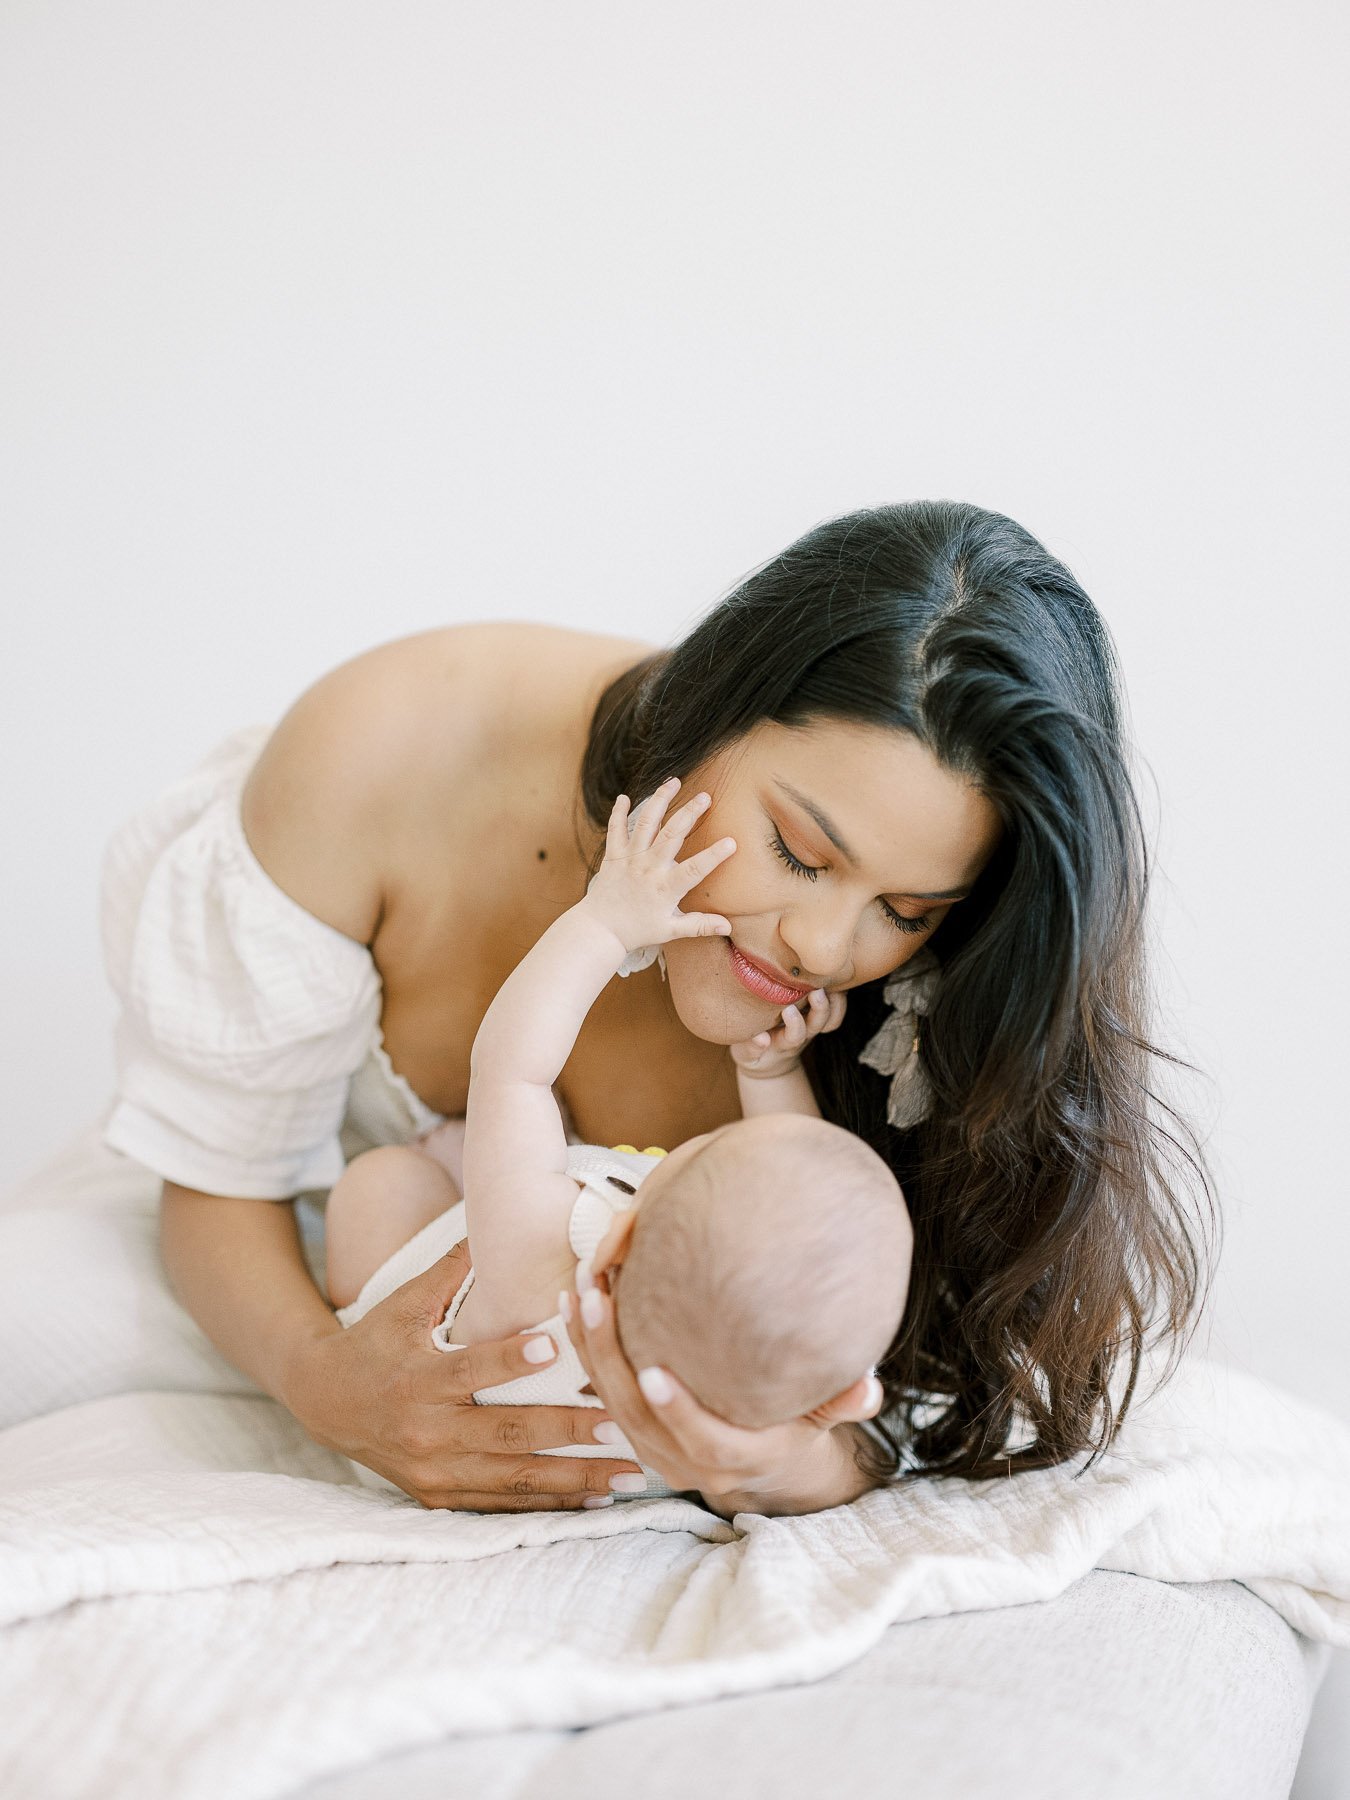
[666,720,999,1044]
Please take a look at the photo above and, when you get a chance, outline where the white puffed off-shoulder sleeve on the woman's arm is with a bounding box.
[101,727,380,1201]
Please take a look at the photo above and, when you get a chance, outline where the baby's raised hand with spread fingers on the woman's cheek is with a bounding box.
[581,776,736,950]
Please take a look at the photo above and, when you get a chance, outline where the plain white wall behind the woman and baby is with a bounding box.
[0,0,1350,1490]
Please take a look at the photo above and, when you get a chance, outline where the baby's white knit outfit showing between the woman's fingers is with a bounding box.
[338,1143,677,1501]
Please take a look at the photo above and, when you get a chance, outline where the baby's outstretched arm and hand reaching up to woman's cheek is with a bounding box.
[464,781,736,1336]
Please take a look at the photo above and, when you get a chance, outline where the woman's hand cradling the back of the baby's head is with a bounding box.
[560,1273,884,1517]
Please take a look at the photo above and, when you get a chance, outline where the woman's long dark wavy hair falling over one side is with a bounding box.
[581,500,1219,1480]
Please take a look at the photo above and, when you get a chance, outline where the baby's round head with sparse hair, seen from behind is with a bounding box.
[608,1114,913,1426]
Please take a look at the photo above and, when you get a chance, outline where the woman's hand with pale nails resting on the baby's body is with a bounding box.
[283,1244,641,1512]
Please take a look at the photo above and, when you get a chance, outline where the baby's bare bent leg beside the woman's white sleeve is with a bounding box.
[324,1145,459,1307]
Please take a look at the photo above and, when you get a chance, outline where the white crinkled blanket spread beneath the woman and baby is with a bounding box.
[0,1361,1350,1800]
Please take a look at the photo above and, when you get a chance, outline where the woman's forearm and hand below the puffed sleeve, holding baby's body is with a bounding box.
[160,1183,637,1512]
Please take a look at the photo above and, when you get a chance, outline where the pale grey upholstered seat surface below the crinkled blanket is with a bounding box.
[297,1571,1324,1800]
